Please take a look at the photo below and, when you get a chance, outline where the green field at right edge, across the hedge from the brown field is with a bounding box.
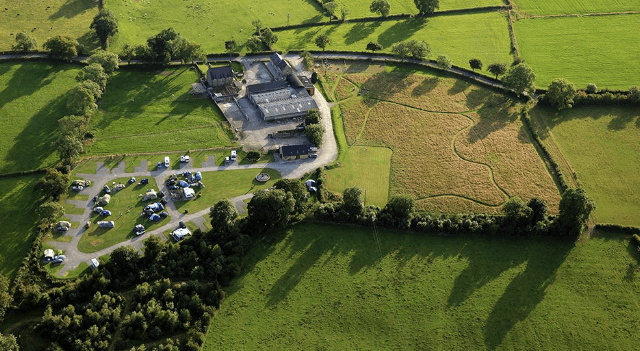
[531,106,640,226]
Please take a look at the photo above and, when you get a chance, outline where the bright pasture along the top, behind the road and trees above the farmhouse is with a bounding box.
[106,0,329,53]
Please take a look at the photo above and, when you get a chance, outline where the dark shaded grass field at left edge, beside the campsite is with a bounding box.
[0,175,41,279]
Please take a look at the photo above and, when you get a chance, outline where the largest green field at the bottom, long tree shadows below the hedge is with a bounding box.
[203,224,640,351]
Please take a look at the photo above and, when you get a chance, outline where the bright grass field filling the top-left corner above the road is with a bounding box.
[0,0,99,51]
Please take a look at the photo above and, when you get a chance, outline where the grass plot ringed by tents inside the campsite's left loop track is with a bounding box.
[78,177,171,253]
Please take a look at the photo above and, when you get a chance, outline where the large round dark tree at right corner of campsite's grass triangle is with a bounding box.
[247,189,296,233]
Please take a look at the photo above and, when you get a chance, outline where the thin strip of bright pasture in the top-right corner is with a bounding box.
[513,0,640,15]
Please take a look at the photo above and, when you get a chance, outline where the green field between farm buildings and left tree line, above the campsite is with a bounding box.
[87,67,236,155]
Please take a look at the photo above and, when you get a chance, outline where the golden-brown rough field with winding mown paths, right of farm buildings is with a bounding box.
[328,67,559,212]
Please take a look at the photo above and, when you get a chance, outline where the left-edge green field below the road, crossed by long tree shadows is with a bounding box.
[0,62,79,173]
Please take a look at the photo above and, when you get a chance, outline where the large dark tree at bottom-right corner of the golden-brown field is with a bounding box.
[554,188,596,238]
